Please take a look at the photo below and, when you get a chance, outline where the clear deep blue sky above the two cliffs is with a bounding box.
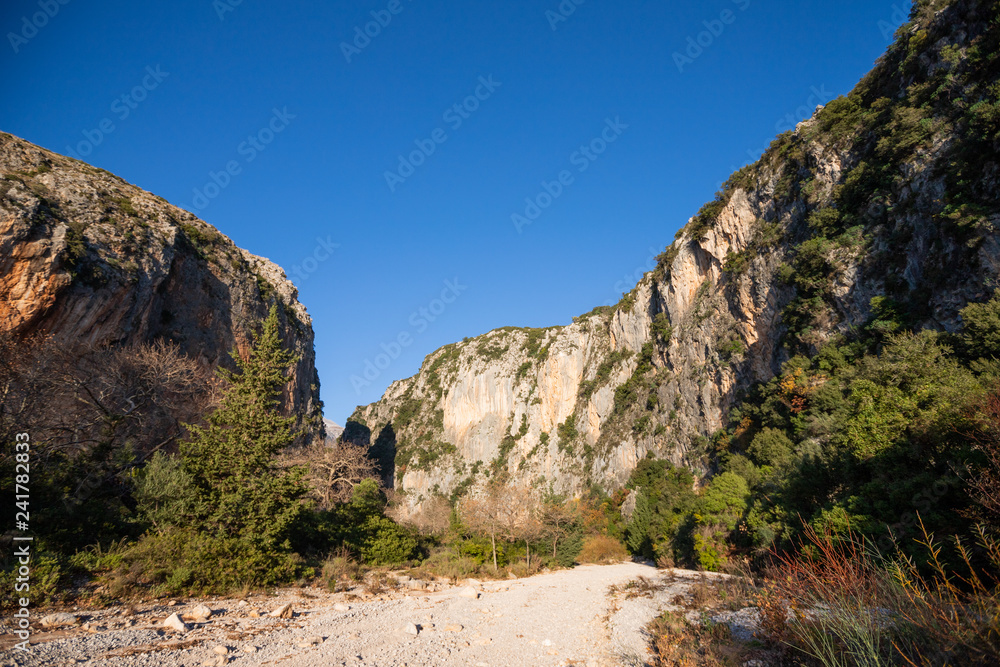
[0,0,909,424]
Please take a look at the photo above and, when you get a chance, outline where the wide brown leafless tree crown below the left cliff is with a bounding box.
[0,333,214,459]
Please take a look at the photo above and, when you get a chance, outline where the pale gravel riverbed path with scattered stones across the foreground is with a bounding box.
[2,563,681,667]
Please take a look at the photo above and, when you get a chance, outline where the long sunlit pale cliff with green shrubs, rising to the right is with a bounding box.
[344,1,1000,507]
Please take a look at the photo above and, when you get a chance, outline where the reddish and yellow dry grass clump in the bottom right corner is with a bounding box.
[758,529,1000,666]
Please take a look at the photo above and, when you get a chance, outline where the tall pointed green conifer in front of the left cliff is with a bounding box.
[180,306,307,549]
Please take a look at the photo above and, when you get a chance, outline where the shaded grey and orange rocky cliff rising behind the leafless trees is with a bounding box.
[0,133,323,436]
